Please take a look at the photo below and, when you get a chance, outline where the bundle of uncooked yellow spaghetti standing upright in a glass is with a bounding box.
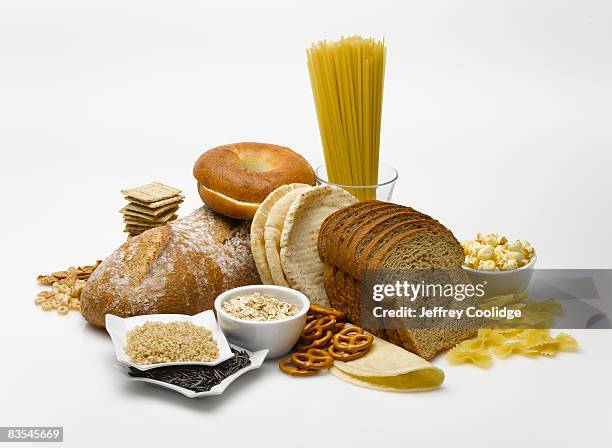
[307,36,386,200]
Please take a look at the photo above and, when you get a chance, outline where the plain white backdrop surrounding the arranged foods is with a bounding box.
[0,0,612,447]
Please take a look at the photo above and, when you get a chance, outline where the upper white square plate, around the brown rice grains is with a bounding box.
[106,310,234,370]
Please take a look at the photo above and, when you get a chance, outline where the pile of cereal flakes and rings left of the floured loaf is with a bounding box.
[34,260,102,315]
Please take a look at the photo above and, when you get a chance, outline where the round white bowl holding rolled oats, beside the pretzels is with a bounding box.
[215,285,310,359]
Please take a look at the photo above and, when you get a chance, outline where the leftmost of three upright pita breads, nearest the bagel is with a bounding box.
[251,184,309,285]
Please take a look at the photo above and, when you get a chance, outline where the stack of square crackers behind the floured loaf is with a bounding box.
[119,182,184,236]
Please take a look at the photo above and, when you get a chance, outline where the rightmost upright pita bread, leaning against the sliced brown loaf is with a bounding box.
[280,185,357,307]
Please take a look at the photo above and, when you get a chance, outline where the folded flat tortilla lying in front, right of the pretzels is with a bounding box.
[330,337,444,392]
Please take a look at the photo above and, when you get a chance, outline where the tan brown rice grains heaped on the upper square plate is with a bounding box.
[125,322,219,364]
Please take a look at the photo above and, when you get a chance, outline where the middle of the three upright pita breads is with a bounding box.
[264,186,314,287]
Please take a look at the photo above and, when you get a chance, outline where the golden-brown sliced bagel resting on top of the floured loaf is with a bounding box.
[193,142,315,220]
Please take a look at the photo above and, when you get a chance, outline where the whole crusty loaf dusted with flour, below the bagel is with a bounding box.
[81,207,260,327]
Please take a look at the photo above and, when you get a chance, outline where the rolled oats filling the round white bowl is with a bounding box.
[221,292,298,321]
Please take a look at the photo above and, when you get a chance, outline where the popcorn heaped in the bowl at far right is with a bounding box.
[462,233,535,271]
